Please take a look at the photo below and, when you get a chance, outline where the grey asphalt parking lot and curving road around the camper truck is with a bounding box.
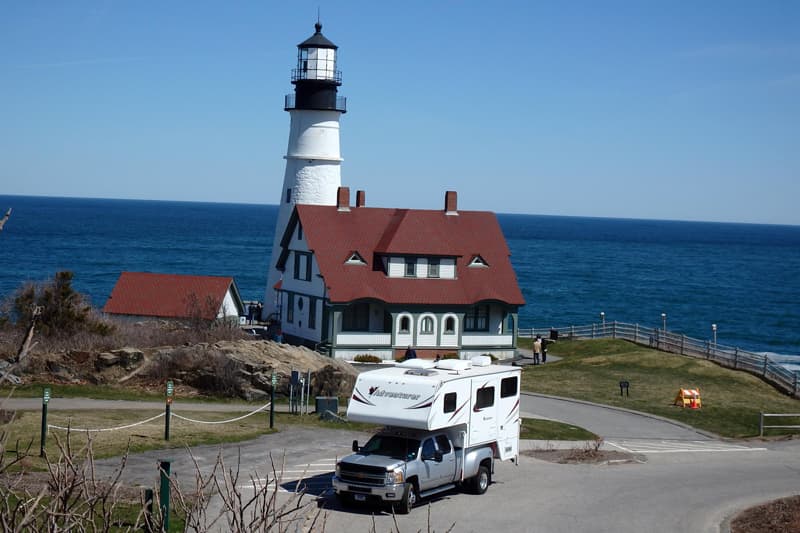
[83,395,800,533]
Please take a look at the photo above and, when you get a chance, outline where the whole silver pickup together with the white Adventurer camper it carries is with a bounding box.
[333,356,521,513]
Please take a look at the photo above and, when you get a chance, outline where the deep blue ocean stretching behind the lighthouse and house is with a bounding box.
[0,196,800,360]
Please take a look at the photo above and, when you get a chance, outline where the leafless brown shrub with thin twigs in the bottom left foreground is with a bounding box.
[0,422,325,533]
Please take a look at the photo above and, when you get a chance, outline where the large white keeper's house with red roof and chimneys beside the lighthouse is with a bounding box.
[275,187,525,359]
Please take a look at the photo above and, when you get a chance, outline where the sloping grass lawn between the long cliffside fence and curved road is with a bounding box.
[522,339,800,437]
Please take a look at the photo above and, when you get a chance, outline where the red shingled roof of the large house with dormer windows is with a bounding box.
[287,205,525,305]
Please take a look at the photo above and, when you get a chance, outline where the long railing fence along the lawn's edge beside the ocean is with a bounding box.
[519,321,800,396]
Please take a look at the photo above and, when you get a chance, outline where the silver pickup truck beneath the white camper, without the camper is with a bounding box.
[333,428,494,514]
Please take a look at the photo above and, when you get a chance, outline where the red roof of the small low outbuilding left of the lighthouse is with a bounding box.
[103,272,238,320]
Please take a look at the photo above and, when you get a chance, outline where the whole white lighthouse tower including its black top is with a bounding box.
[264,22,346,318]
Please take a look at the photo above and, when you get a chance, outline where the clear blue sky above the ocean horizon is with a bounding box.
[0,0,800,224]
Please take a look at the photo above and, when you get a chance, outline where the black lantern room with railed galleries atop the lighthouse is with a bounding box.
[285,22,346,113]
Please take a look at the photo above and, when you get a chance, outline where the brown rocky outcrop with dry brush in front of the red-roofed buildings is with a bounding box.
[22,339,358,401]
